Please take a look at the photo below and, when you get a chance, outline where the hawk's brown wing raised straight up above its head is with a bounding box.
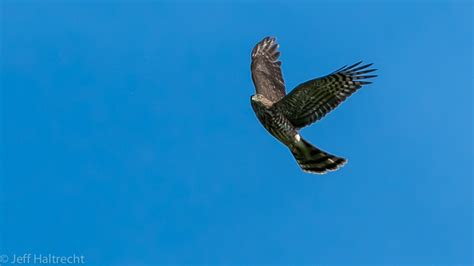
[250,37,286,102]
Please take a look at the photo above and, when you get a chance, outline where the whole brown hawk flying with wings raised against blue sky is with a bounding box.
[250,37,376,174]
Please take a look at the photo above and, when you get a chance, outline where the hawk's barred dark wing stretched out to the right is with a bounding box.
[275,61,377,128]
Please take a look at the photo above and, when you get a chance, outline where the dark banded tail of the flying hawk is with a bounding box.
[290,139,347,174]
